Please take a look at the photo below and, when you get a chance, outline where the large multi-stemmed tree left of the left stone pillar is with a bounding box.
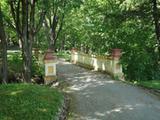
[9,0,45,82]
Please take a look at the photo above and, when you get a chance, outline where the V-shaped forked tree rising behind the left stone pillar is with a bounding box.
[45,0,67,50]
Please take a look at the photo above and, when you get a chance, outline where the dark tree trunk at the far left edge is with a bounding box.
[0,6,8,83]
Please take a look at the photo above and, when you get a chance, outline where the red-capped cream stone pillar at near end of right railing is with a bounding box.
[112,49,123,80]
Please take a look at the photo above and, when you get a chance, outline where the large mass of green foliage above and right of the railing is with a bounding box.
[60,0,160,80]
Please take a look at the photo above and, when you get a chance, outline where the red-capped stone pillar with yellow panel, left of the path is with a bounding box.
[44,50,57,84]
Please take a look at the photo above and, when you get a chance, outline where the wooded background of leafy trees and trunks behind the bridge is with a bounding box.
[0,0,160,83]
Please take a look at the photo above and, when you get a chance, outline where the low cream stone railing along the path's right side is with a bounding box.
[71,51,123,79]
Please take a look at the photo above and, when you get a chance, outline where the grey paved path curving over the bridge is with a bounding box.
[58,62,160,120]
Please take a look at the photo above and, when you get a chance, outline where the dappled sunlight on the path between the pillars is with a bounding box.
[57,62,115,93]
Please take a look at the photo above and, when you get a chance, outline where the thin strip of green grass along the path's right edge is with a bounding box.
[134,80,160,89]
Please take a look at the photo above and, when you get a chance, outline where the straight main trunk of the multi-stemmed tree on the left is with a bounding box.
[21,0,32,82]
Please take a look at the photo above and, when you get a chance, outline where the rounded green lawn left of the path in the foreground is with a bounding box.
[0,84,63,120]
